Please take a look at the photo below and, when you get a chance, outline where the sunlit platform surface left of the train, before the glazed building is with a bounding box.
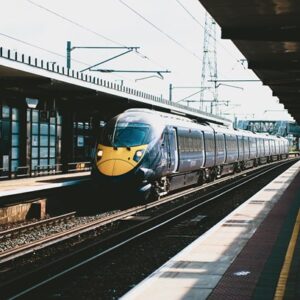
[0,171,91,200]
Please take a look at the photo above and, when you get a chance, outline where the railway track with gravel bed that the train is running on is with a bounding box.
[0,157,296,265]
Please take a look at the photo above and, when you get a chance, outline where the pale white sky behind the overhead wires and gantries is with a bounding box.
[0,0,292,120]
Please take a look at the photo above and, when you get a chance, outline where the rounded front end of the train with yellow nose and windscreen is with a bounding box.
[92,112,162,200]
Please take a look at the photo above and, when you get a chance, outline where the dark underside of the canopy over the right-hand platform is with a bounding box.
[199,0,300,123]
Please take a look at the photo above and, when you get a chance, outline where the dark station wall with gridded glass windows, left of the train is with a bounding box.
[0,97,95,179]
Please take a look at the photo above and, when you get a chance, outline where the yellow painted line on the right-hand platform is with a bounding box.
[274,209,300,300]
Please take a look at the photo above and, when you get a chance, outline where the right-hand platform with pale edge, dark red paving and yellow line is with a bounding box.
[121,161,300,300]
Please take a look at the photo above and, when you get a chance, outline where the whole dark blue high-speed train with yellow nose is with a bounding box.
[92,109,288,200]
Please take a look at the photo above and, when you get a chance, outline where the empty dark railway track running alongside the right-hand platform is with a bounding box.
[0,161,291,299]
